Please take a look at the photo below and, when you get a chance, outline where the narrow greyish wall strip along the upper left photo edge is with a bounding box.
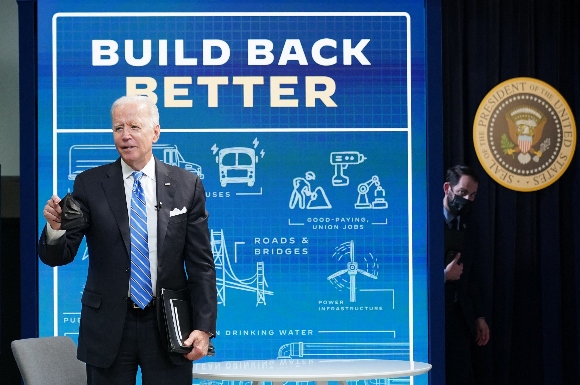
[0,0,20,176]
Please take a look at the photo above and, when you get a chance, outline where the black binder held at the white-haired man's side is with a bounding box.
[161,289,215,356]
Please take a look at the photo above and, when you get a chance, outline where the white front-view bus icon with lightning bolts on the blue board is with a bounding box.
[216,147,258,187]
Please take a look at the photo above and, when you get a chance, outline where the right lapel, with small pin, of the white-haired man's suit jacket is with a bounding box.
[155,158,176,256]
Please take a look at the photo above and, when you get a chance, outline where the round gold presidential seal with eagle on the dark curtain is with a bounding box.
[473,78,576,191]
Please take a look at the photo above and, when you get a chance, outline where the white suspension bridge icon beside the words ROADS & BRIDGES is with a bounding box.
[211,230,274,306]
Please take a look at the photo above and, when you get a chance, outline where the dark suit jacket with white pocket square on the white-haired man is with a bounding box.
[39,158,217,367]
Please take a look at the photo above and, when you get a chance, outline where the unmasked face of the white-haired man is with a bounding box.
[113,103,160,171]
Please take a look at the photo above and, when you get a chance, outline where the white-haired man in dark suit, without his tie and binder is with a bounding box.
[39,96,217,385]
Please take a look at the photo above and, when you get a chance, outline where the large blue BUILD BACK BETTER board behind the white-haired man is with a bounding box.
[38,0,428,384]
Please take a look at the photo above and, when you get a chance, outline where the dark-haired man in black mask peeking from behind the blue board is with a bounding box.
[443,166,489,385]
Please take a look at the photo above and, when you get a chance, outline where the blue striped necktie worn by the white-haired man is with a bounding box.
[130,171,153,309]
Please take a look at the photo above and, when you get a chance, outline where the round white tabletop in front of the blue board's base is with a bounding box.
[193,359,431,385]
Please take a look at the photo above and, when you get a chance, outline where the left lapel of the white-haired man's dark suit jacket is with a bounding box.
[101,158,131,255]
